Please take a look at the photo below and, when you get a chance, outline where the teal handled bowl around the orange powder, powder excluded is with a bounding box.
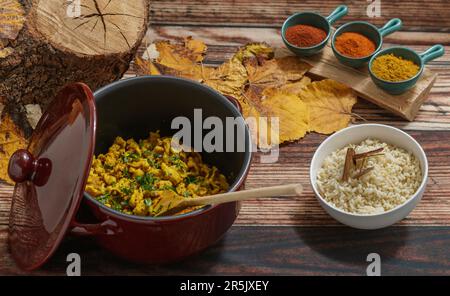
[331,18,402,68]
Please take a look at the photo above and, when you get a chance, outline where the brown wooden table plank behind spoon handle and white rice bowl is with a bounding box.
[0,131,450,226]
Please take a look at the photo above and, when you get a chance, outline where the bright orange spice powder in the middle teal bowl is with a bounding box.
[334,32,375,58]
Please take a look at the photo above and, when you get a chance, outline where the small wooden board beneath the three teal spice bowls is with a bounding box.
[277,44,437,121]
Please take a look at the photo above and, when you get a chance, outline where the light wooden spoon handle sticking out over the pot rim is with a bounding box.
[183,184,303,206]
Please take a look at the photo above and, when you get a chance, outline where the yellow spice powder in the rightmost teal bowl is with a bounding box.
[371,54,420,82]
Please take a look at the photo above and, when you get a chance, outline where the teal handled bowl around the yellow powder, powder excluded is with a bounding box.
[369,44,445,95]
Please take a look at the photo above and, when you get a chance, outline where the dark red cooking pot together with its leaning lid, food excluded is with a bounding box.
[10,76,252,269]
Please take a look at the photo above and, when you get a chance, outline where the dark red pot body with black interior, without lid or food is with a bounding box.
[75,76,251,263]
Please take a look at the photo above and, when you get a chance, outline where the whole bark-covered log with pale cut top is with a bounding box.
[0,0,149,135]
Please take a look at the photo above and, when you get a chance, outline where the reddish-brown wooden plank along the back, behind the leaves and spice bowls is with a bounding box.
[150,0,450,32]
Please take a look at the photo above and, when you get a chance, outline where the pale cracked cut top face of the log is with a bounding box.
[31,0,147,56]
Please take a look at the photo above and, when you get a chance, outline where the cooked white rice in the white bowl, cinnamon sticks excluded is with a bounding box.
[317,139,422,215]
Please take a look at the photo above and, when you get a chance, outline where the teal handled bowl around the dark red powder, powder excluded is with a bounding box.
[281,5,348,56]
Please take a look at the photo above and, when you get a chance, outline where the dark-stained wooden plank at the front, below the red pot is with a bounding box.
[0,226,450,275]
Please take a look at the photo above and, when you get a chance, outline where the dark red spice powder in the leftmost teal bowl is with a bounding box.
[285,25,327,47]
